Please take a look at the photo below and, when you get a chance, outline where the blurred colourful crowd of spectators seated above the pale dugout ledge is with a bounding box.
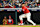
[0,0,40,8]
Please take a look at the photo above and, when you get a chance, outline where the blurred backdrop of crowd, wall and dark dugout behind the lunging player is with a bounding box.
[0,0,40,25]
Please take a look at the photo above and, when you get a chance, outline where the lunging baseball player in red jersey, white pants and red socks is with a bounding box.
[17,3,36,25]
